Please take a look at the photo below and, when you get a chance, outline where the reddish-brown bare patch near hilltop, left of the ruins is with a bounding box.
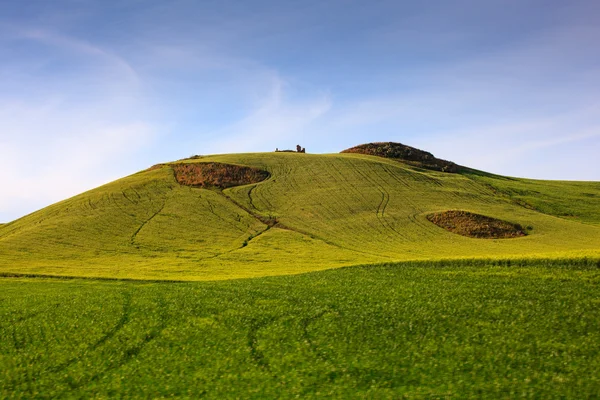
[171,162,270,189]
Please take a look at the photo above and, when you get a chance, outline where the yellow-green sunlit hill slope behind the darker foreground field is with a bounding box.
[0,153,600,280]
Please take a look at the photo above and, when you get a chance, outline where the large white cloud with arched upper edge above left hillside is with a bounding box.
[0,28,157,221]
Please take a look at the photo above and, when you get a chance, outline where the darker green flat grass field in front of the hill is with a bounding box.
[0,262,600,398]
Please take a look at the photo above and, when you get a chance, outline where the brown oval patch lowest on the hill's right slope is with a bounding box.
[427,211,526,239]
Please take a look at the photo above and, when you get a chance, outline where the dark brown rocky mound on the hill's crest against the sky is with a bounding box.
[342,142,462,173]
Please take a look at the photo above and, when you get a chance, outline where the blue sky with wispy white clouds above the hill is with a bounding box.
[0,0,600,222]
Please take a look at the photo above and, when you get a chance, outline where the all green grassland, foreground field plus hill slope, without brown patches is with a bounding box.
[0,149,600,399]
